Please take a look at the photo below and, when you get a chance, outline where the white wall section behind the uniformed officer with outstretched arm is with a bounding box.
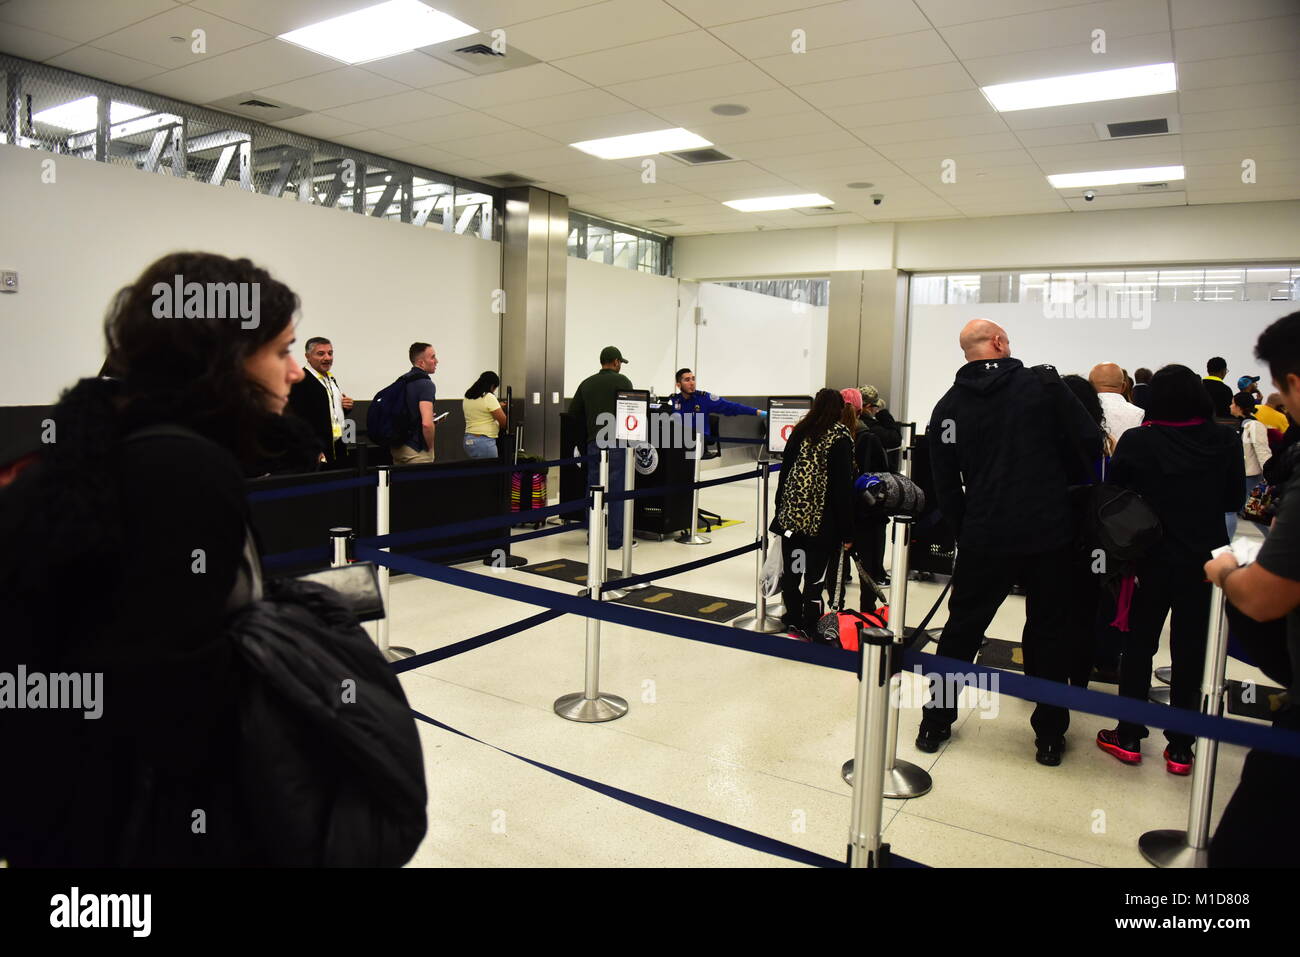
[683,282,827,397]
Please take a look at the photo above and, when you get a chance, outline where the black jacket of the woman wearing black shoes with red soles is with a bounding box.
[1106,423,1245,566]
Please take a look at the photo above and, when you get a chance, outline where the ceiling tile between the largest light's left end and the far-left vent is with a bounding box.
[142,40,338,105]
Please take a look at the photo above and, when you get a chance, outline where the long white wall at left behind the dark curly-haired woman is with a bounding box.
[0,146,501,406]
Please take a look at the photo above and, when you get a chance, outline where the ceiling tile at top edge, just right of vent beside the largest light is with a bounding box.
[508,0,697,61]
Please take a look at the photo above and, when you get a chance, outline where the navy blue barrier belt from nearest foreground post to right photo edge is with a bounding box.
[902,650,1300,758]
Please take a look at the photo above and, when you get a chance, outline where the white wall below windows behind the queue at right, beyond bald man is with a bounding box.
[905,302,1295,429]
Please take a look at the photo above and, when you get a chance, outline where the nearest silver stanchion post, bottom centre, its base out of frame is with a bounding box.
[849,623,894,867]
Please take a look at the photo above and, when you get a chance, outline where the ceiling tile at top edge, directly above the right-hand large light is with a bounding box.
[940,0,1169,61]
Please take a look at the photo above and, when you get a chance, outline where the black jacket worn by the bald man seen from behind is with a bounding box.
[927,359,1101,554]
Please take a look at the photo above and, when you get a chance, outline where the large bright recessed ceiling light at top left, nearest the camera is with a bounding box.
[280,0,478,64]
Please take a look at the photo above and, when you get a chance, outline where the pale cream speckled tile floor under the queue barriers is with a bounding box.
[377,460,1262,867]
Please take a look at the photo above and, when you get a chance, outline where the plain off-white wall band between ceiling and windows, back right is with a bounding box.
[673,200,1300,280]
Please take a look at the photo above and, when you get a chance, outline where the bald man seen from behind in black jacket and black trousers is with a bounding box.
[917,319,1101,766]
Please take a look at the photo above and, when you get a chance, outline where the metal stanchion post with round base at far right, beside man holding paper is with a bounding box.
[1138,585,1227,867]
